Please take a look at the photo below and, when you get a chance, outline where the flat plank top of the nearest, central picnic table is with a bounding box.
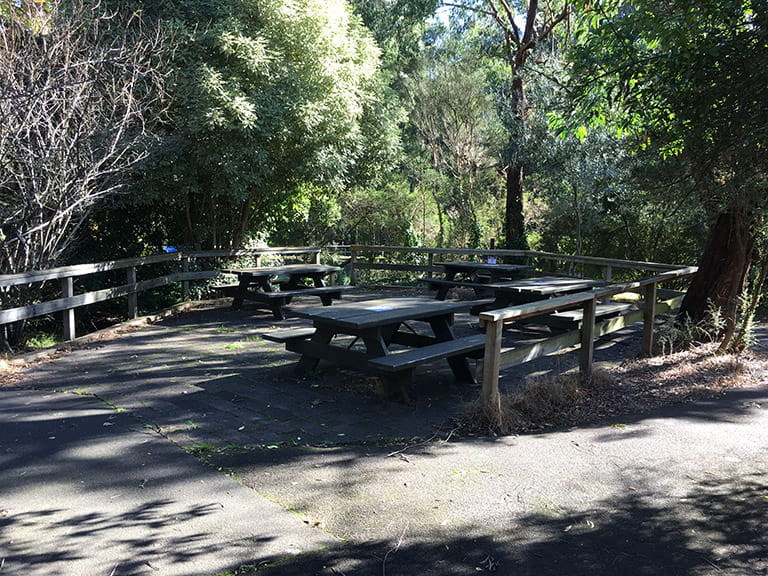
[293,297,484,329]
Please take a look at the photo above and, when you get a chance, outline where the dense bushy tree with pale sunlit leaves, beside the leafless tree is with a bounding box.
[126,0,388,249]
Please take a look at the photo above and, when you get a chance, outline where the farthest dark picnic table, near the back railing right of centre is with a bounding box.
[422,261,533,300]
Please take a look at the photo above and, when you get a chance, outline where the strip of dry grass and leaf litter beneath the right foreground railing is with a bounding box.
[459,345,768,435]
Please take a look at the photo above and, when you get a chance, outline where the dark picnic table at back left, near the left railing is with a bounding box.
[216,264,349,320]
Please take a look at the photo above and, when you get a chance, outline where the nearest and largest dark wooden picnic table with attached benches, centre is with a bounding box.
[262,297,492,392]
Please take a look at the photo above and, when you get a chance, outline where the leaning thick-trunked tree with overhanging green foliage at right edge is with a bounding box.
[574,0,768,348]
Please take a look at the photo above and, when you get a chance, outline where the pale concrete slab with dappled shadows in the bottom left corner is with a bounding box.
[0,387,337,576]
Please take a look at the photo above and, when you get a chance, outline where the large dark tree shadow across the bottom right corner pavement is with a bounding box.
[250,475,768,576]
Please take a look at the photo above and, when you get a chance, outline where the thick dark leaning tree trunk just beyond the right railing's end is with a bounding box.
[678,212,754,350]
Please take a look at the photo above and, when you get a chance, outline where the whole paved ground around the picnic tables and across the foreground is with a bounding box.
[0,294,768,575]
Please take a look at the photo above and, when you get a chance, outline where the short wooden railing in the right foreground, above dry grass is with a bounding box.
[478,266,697,417]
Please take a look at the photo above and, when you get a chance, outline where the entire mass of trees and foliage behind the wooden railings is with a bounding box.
[0,0,768,348]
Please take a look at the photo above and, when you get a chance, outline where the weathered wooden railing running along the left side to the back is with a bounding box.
[0,247,321,340]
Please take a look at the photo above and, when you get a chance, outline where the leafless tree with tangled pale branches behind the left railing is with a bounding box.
[0,0,164,340]
